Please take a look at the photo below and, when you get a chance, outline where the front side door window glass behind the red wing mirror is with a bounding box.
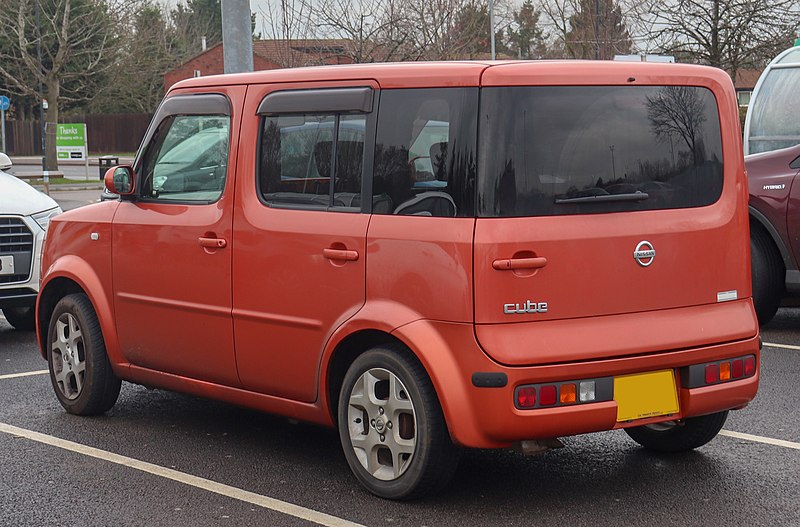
[141,115,230,203]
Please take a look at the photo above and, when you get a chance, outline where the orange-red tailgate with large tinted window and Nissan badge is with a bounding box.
[474,65,750,364]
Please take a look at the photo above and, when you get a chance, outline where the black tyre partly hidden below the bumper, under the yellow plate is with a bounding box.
[625,410,728,452]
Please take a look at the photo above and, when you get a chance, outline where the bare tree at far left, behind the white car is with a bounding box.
[0,0,124,170]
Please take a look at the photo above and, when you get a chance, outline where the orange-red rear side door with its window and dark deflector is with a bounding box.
[233,80,377,402]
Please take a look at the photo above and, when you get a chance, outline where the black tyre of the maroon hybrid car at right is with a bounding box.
[750,224,786,325]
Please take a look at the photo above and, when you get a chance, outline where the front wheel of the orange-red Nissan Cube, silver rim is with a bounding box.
[47,294,122,415]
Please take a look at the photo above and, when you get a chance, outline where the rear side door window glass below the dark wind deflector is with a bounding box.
[259,115,366,208]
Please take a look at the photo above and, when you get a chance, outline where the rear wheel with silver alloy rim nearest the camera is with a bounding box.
[338,345,459,500]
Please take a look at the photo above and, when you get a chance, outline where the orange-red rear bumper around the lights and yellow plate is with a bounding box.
[399,322,760,448]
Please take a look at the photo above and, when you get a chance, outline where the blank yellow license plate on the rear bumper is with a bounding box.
[614,370,678,422]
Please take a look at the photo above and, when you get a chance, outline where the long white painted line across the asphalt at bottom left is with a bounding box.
[0,423,363,527]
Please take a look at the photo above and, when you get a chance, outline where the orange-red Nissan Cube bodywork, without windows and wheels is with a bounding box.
[38,62,764,500]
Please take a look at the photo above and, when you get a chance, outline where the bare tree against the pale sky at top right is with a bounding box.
[642,0,800,78]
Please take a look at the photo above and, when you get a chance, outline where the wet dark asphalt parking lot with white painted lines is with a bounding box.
[0,308,800,526]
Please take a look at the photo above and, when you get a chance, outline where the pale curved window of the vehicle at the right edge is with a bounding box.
[748,67,800,154]
